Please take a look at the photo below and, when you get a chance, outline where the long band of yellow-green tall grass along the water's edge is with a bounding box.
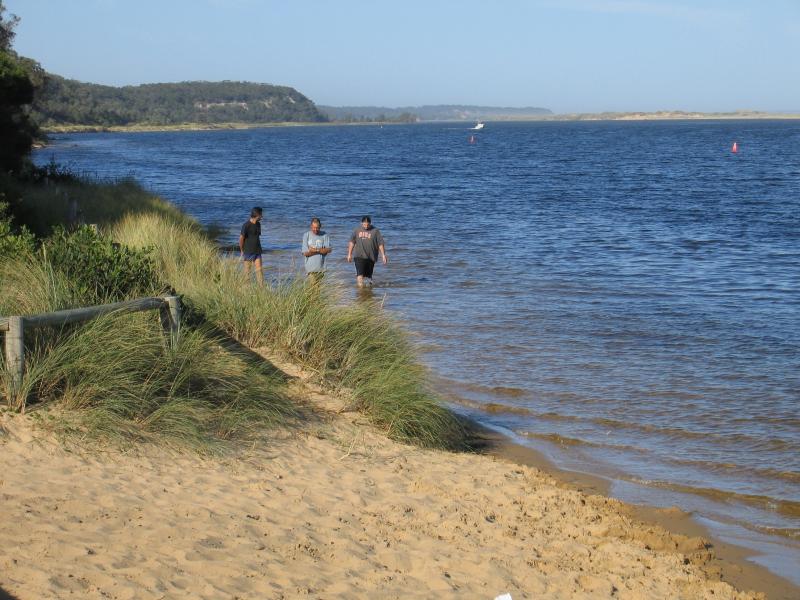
[112,215,465,448]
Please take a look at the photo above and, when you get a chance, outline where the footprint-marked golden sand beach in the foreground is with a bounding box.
[0,350,791,600]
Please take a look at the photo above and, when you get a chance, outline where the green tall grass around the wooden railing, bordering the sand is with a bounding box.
[0,253,293,451]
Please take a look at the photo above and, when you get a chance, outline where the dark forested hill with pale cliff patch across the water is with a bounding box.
[32,74,327,127]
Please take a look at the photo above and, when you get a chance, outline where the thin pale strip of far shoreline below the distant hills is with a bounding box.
[42,111,800,133]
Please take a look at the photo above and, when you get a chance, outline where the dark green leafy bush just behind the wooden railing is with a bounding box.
[42,226,164,303]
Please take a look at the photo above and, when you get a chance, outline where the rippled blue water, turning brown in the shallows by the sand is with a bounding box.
[35,121,800,581]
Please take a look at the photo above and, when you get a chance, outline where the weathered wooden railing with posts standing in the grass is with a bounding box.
[0,296,181,395]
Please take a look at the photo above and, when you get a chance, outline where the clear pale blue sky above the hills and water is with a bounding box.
[5,0,800,112]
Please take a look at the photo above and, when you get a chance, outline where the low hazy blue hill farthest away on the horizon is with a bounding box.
[318,104,553,121]
